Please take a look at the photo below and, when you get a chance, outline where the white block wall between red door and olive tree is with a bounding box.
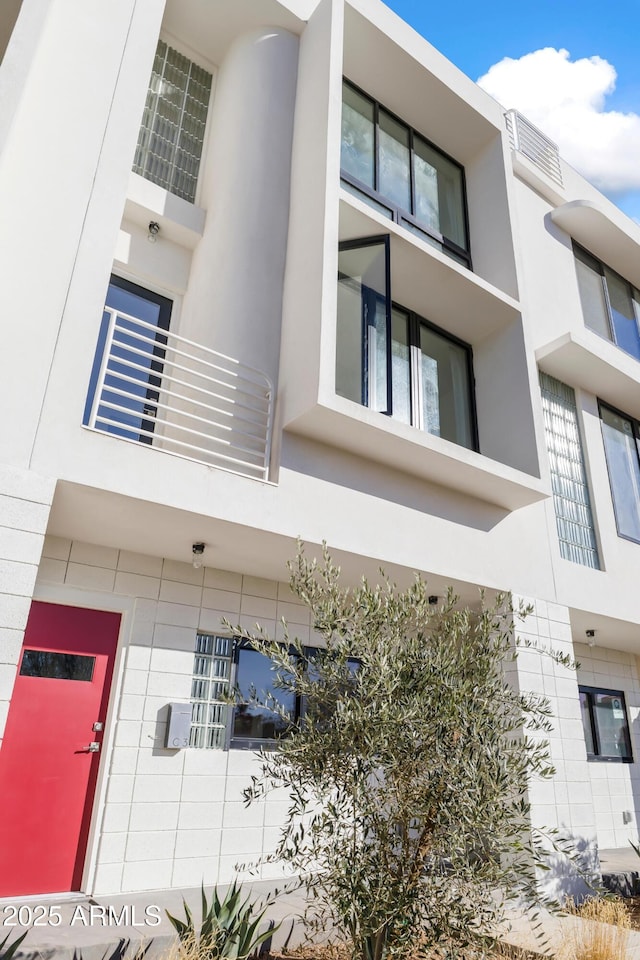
[35,537,309,894]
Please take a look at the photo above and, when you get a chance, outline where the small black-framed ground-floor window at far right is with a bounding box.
[580,686,633,763]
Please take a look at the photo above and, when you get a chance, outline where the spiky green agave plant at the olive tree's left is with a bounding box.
[166,882,279,960]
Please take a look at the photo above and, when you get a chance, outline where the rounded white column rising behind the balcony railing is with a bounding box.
[180,28,303,390]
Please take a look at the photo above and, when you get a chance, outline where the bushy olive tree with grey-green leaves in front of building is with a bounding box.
[228,548,566,960]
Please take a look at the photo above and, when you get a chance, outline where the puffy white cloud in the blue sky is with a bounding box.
[478,47,640,194]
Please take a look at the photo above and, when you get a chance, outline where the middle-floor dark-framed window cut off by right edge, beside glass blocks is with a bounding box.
[600,403,640,543]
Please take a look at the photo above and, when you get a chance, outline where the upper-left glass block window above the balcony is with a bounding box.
[133,40,212,203]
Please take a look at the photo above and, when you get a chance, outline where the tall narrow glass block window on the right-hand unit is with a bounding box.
[540,372,600,570]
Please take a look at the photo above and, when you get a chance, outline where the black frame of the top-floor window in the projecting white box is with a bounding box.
[340,77,473,270]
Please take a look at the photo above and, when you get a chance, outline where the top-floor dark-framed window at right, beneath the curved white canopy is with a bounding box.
[573,244,640,360]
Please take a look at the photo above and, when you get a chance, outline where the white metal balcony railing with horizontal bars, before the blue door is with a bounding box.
[85,307,273,480]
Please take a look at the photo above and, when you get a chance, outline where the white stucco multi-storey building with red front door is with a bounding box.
[0,0,640,897]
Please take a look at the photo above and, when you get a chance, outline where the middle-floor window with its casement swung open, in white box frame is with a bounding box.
[336,237,477,449]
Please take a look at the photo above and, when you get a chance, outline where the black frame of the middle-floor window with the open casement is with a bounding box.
[338,234,480,453]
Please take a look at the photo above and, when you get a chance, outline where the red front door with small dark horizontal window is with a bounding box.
[0,602,120,897]
